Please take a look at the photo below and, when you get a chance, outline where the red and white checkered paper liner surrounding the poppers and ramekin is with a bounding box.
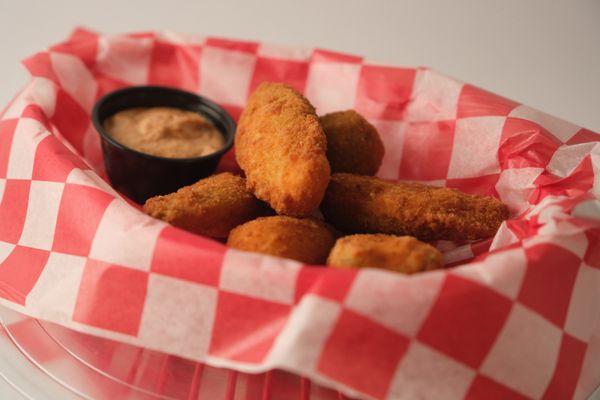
[0,26,600,399]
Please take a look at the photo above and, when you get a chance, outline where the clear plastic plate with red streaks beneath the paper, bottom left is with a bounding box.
[0,307,346,400]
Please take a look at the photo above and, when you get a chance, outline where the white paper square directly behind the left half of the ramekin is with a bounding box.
[96,35,154,85]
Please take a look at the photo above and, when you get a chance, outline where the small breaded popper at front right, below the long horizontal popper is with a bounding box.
[327,234,443,274]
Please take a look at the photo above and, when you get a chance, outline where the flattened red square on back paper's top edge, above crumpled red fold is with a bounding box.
[456,85,519,118]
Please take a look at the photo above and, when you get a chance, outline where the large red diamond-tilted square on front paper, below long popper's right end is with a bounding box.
[418,275,512,368]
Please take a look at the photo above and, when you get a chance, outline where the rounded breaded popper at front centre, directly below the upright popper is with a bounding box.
[227,215,336,264]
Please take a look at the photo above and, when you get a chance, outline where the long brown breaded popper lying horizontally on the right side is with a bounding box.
[321,174,508,240]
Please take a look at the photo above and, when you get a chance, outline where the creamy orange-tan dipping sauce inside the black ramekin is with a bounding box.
[104,107,225,158]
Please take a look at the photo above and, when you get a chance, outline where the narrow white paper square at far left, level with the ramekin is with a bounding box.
[6,118,50,179]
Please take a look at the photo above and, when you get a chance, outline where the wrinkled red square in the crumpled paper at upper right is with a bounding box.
[498,117,561,170]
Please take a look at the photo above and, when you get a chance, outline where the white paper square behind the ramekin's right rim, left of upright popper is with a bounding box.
[199,46,256,106]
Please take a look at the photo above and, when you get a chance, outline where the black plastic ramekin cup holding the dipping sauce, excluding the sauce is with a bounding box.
[92,86,236,204]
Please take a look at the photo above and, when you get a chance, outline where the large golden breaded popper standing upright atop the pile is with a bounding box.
[235,83,329,217]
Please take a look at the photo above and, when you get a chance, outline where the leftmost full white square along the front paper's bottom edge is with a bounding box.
[25,253,86,323]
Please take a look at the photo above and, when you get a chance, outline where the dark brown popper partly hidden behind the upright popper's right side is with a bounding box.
[319,110,385,175]
